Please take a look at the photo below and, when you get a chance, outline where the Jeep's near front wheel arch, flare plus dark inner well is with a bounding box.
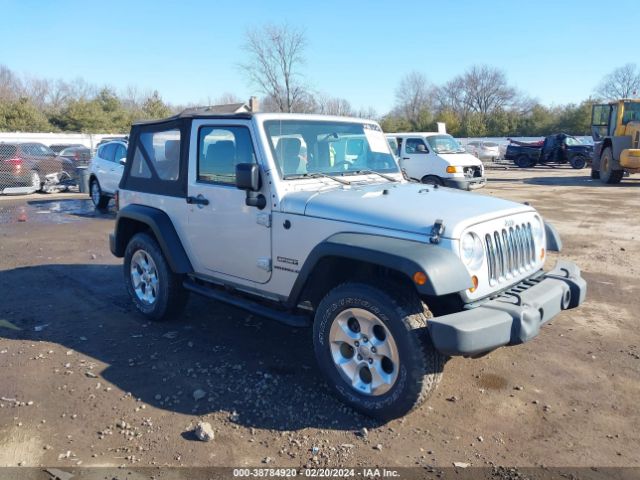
[287,233,473,308]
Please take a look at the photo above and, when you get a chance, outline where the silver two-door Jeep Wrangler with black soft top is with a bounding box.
[110,109,586,420]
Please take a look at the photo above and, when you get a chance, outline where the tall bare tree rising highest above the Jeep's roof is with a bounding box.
[240,25,308,112]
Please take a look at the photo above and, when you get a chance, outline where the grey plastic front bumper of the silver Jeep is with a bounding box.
[427,261,587,356]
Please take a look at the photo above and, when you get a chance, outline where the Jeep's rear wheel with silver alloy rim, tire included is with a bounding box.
[124,233,189,321]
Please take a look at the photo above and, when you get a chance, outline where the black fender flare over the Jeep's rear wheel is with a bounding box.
[109,204,193,273]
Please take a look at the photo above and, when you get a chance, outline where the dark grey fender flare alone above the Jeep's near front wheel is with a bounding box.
[287,233,473,304]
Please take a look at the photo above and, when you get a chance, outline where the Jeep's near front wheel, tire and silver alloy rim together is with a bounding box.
[313,283,446,420]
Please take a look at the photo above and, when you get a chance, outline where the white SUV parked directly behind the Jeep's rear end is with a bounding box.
[89,140,127,208]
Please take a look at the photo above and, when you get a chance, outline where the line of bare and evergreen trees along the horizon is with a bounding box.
[0,25,640,137]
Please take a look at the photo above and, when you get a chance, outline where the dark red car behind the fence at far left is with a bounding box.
[0,142,64,193]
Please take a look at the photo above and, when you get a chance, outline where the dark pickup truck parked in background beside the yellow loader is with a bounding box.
[504,133,593,169]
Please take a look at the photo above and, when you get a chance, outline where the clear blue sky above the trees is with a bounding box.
[0,0,640,113]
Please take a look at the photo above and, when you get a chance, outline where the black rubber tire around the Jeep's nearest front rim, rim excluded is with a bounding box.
[313,283,447,421]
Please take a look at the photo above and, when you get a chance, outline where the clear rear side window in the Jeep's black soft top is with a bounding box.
[139,129,180,180]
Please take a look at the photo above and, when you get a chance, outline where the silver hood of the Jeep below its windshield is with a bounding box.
[281,183,534,239]
